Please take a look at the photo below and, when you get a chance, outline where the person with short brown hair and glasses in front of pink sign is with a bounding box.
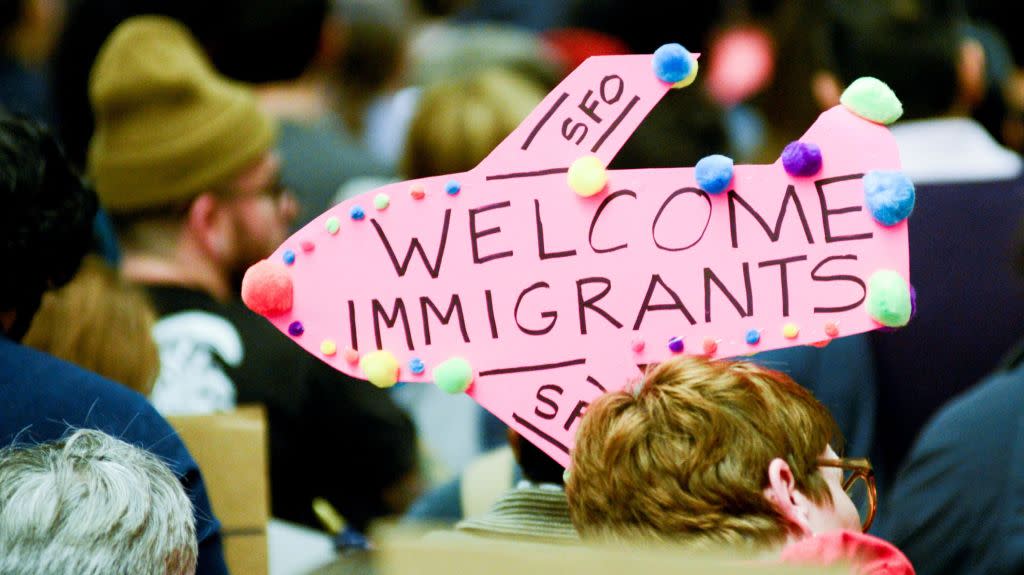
[565,356,913,575]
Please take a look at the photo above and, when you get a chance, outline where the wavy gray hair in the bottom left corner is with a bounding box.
[0,430,198,575]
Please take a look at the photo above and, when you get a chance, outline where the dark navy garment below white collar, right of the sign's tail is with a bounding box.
[871,178,1024,478]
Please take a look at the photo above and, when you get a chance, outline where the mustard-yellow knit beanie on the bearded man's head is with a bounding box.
[88,16,274,213]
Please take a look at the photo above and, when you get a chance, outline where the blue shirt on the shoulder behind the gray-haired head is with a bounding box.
[0,335,227,575]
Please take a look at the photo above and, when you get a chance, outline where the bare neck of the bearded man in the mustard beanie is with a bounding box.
[121,250,231,302]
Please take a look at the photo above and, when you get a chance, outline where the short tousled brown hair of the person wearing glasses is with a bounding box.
[566,356,839,547]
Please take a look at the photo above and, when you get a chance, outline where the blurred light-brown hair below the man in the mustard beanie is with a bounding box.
[24,256,160,396]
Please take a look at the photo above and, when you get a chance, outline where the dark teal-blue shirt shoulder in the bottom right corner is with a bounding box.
[876,347,1024,575]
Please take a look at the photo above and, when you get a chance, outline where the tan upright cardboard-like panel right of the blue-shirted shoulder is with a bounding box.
[167,406,270,575]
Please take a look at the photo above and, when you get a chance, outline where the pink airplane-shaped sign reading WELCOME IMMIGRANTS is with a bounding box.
[241,55,908,465]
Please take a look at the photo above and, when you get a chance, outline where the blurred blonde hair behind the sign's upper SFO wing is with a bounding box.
[400,69,547,179]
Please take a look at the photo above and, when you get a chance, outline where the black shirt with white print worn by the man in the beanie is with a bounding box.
[148,286,416,530]
